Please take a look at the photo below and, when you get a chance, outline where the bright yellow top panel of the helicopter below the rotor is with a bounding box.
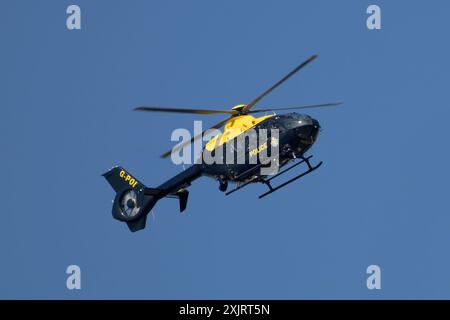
[205,115,273,151]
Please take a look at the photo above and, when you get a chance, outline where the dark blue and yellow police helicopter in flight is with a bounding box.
[103,55,341,232]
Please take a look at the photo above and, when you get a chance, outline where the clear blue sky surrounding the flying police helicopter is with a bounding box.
[0,0,450,299]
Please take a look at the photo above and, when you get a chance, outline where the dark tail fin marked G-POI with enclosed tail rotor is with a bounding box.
[103,166,164,232]
